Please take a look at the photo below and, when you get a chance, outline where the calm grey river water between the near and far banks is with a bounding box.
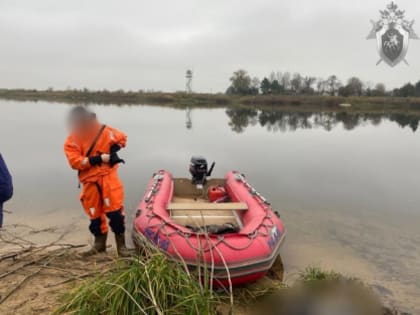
[0,101,420,313]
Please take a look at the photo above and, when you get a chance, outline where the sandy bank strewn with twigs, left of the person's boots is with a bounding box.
[0,212,127,315]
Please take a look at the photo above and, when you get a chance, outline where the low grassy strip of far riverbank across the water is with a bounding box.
[0,89,420,116]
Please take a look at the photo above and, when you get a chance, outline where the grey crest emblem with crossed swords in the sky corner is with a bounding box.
[367,2,419,67]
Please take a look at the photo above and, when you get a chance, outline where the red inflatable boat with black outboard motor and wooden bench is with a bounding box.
[133,158,286,287]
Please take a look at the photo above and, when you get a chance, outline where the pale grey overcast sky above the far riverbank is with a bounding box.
[0,0,420,92]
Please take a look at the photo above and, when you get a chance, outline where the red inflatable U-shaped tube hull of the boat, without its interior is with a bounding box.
[133,171,286,286]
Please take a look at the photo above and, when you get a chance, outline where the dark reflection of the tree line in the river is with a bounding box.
[226,108,420,133]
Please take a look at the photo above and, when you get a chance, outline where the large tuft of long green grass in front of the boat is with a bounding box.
[54,242,218,315]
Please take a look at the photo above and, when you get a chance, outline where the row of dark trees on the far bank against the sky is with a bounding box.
[226,69,420,97]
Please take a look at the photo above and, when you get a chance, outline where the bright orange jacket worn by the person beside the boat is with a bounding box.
[64,122,127,183]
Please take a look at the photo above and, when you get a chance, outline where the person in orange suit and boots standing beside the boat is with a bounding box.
[64,106,129,257]
